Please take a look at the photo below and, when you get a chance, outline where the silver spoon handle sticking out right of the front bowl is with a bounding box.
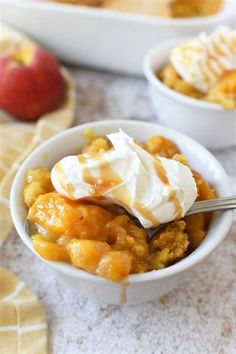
[186,196,236,215]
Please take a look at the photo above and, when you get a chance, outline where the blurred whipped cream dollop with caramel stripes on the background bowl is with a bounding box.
[170,26,236,94]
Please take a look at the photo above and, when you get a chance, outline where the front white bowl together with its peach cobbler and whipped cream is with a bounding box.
[11,121,231,303]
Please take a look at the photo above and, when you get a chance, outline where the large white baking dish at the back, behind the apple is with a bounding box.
[0,0,232,74]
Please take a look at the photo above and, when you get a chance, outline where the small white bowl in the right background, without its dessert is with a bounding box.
[143,37,236,148]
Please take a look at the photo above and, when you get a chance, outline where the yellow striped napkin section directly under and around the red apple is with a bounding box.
[0,23,76,244]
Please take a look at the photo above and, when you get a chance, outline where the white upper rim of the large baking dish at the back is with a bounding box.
[8,0,231,28]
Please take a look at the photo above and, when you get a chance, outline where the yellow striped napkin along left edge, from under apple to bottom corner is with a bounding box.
[0,23,76,354]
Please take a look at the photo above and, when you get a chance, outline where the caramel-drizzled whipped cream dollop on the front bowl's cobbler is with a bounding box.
[51,130,197,228]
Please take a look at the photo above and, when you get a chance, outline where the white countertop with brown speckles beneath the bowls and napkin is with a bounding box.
[0,68,236,354]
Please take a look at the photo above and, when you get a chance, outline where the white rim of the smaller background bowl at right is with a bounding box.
[143,36,236,112]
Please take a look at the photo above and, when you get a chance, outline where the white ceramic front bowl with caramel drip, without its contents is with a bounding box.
[10,120,232,304]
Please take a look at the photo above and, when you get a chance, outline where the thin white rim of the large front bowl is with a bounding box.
[10,120,233,285]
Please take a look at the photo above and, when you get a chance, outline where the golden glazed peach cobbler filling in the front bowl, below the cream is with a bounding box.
[24,136,216,282]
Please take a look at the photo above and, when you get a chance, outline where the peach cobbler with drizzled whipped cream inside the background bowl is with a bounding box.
[157,27,236,109]
